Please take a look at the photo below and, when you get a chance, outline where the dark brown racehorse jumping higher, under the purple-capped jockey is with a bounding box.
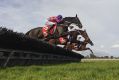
[26,15,82,44]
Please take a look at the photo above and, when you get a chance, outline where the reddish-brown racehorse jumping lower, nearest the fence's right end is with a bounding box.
[65,30,94,54]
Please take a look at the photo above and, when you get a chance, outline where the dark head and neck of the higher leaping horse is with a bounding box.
[63,14,82,28]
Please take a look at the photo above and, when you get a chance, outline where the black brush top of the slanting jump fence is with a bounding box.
[0,27,81,57]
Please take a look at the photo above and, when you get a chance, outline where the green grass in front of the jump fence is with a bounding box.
[0,60,119,80]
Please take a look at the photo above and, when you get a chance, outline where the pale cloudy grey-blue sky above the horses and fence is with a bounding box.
[0,0,119,57]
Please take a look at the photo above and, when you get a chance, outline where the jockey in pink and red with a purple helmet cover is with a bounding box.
[42,15,63,37]
